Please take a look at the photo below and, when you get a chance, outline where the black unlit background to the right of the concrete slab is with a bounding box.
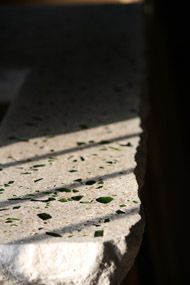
[144,1,190,285]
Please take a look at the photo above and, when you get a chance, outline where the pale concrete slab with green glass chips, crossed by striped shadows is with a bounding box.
[0,5,145,285]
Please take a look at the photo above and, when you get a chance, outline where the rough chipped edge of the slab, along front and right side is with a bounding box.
[0,71,150,285]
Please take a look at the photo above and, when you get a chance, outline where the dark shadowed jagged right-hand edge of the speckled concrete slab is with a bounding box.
[116,77,150,285]
